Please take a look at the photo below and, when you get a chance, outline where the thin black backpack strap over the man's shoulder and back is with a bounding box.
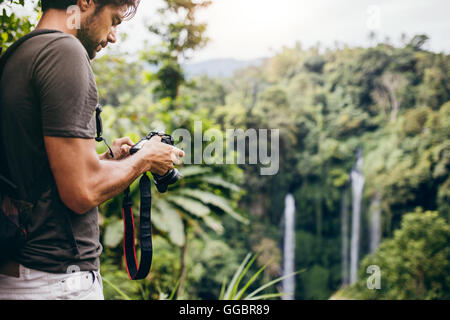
[0,29,61,198]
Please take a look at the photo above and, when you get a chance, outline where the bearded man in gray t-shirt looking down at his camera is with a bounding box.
[0,0,184,299]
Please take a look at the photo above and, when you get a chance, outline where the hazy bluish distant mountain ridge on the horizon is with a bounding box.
[183,58,265,78]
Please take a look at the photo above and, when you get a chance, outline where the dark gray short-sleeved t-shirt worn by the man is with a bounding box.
[0,32,102,273]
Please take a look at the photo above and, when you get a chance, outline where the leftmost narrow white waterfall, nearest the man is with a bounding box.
[281,193,295,300]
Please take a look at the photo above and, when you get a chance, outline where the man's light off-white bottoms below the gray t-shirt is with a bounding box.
[0,265,104,300]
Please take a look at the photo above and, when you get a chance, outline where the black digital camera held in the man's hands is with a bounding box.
[130,131,182,193]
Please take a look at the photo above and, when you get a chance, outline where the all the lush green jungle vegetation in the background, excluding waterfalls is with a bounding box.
[0,0,450,299]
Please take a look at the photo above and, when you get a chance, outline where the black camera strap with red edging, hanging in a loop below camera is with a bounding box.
[122,173,153,280]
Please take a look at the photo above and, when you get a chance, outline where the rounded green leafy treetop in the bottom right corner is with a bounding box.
[338,209,450,300]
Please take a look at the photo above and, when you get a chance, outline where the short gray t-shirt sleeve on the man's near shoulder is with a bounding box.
[33,35,98,139]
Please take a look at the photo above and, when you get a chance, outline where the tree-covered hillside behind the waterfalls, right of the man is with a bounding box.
[184,36,450,299]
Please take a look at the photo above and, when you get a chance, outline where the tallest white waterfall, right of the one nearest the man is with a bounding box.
[350,148,364,283]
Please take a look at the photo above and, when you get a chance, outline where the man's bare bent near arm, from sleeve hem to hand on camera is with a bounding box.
[44,137,184,214]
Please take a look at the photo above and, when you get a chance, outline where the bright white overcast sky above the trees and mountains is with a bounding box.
[17,0,450,62]
